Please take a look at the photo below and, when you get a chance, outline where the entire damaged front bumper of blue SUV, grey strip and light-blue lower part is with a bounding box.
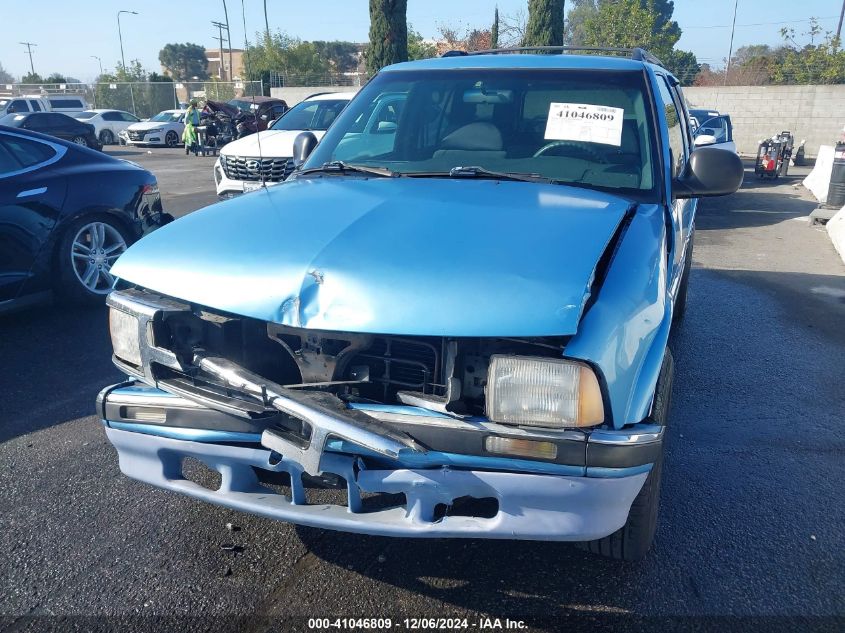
[98,383,663,541]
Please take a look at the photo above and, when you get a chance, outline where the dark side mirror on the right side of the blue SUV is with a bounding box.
[672,147,745,198]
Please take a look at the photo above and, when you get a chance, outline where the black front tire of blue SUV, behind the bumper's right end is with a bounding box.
[578,347,675,561]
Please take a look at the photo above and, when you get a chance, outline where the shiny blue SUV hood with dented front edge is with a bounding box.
[112,176,629,336]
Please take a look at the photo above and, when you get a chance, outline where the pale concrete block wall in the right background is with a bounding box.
[684,85,845,158]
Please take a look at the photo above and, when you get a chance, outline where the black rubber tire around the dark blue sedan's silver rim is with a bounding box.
[54,214,134,305]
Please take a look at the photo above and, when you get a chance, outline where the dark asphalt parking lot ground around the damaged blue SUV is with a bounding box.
[0,148,845,631]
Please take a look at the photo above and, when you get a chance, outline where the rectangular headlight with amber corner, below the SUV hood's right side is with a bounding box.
[486,355,604,428]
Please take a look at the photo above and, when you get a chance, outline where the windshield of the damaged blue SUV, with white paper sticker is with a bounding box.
[304,69,656,198]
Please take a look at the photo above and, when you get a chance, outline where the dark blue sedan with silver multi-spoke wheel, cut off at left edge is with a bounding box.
[0,126,172,313]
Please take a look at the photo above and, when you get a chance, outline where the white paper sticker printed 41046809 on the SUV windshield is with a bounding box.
[545,103,625,147]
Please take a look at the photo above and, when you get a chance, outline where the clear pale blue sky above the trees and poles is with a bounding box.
[0,0,842,81]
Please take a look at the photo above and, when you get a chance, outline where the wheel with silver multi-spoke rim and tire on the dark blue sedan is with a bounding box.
[57,216,132,303]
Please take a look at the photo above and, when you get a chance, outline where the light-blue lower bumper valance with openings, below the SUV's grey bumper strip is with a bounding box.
[106,427,647,541]
